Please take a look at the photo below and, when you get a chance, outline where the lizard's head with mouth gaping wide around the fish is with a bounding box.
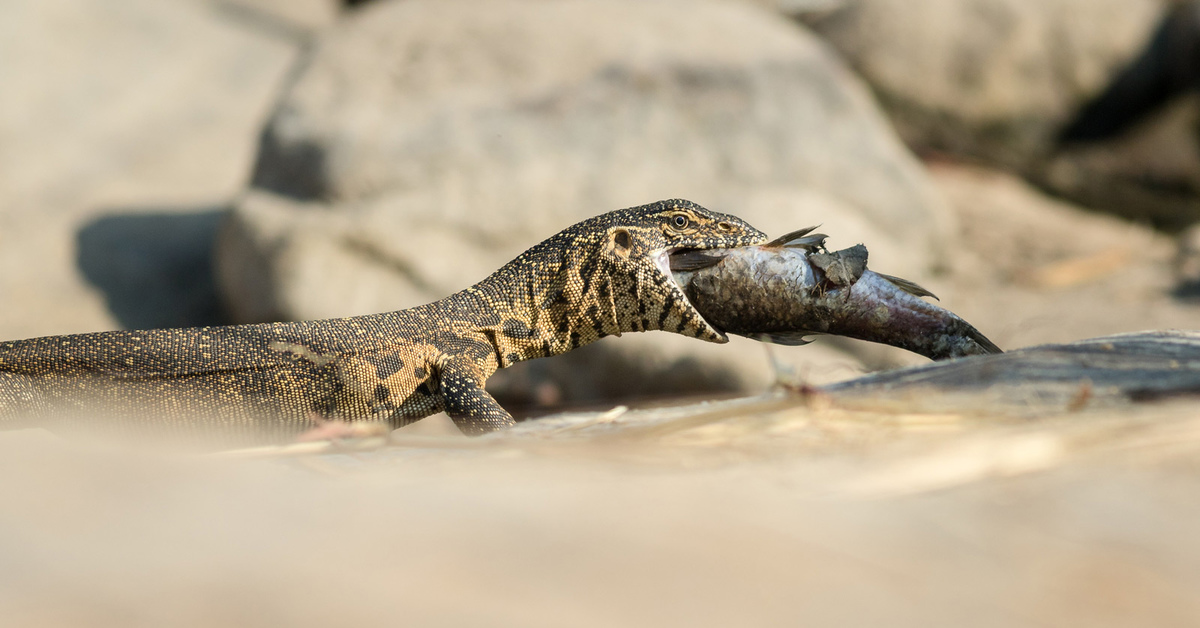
[596,199,767,342]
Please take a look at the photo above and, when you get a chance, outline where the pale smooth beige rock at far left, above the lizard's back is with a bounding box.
[0,0,296,339]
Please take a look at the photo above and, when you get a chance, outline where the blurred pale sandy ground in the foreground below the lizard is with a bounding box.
[0,396,1200,627]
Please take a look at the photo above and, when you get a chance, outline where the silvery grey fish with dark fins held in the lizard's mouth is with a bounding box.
[668,227,1002,360]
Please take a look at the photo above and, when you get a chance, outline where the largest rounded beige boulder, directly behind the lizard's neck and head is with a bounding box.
[217,0,952,400]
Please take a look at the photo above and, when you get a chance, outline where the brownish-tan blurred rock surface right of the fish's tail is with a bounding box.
[930,165,1200,349]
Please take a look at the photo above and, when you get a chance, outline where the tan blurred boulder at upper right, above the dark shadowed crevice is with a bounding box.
[811,0,1163,169]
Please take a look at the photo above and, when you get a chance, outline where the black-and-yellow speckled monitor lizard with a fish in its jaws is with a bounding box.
[0,201,766,442]
